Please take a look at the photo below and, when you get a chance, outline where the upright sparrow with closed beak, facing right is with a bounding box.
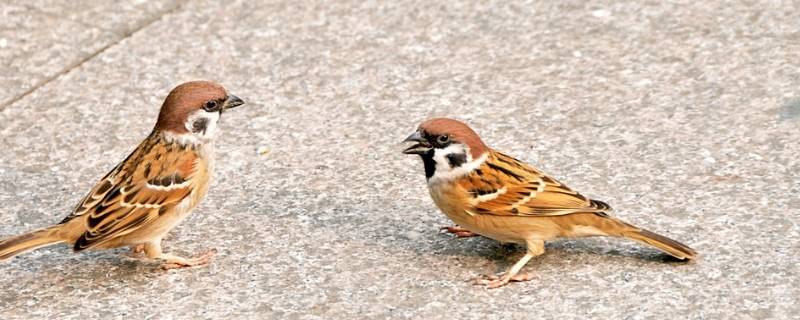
[0,81,244,269]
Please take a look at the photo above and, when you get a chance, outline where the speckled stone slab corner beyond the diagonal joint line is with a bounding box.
[0,0,179,108]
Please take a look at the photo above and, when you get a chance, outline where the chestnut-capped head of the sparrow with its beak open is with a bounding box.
[403,118,489,182]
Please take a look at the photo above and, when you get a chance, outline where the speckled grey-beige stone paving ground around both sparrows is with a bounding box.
[0,0,800,319]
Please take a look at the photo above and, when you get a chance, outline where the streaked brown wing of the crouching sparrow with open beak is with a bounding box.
[461,152,611,216]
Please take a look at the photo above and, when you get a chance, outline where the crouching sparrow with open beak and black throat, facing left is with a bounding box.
[403,118,697,288]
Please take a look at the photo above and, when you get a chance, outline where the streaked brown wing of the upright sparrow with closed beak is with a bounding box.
[64,135,198,251]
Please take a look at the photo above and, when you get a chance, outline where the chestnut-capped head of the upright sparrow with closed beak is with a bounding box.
[155,81,244,141]
